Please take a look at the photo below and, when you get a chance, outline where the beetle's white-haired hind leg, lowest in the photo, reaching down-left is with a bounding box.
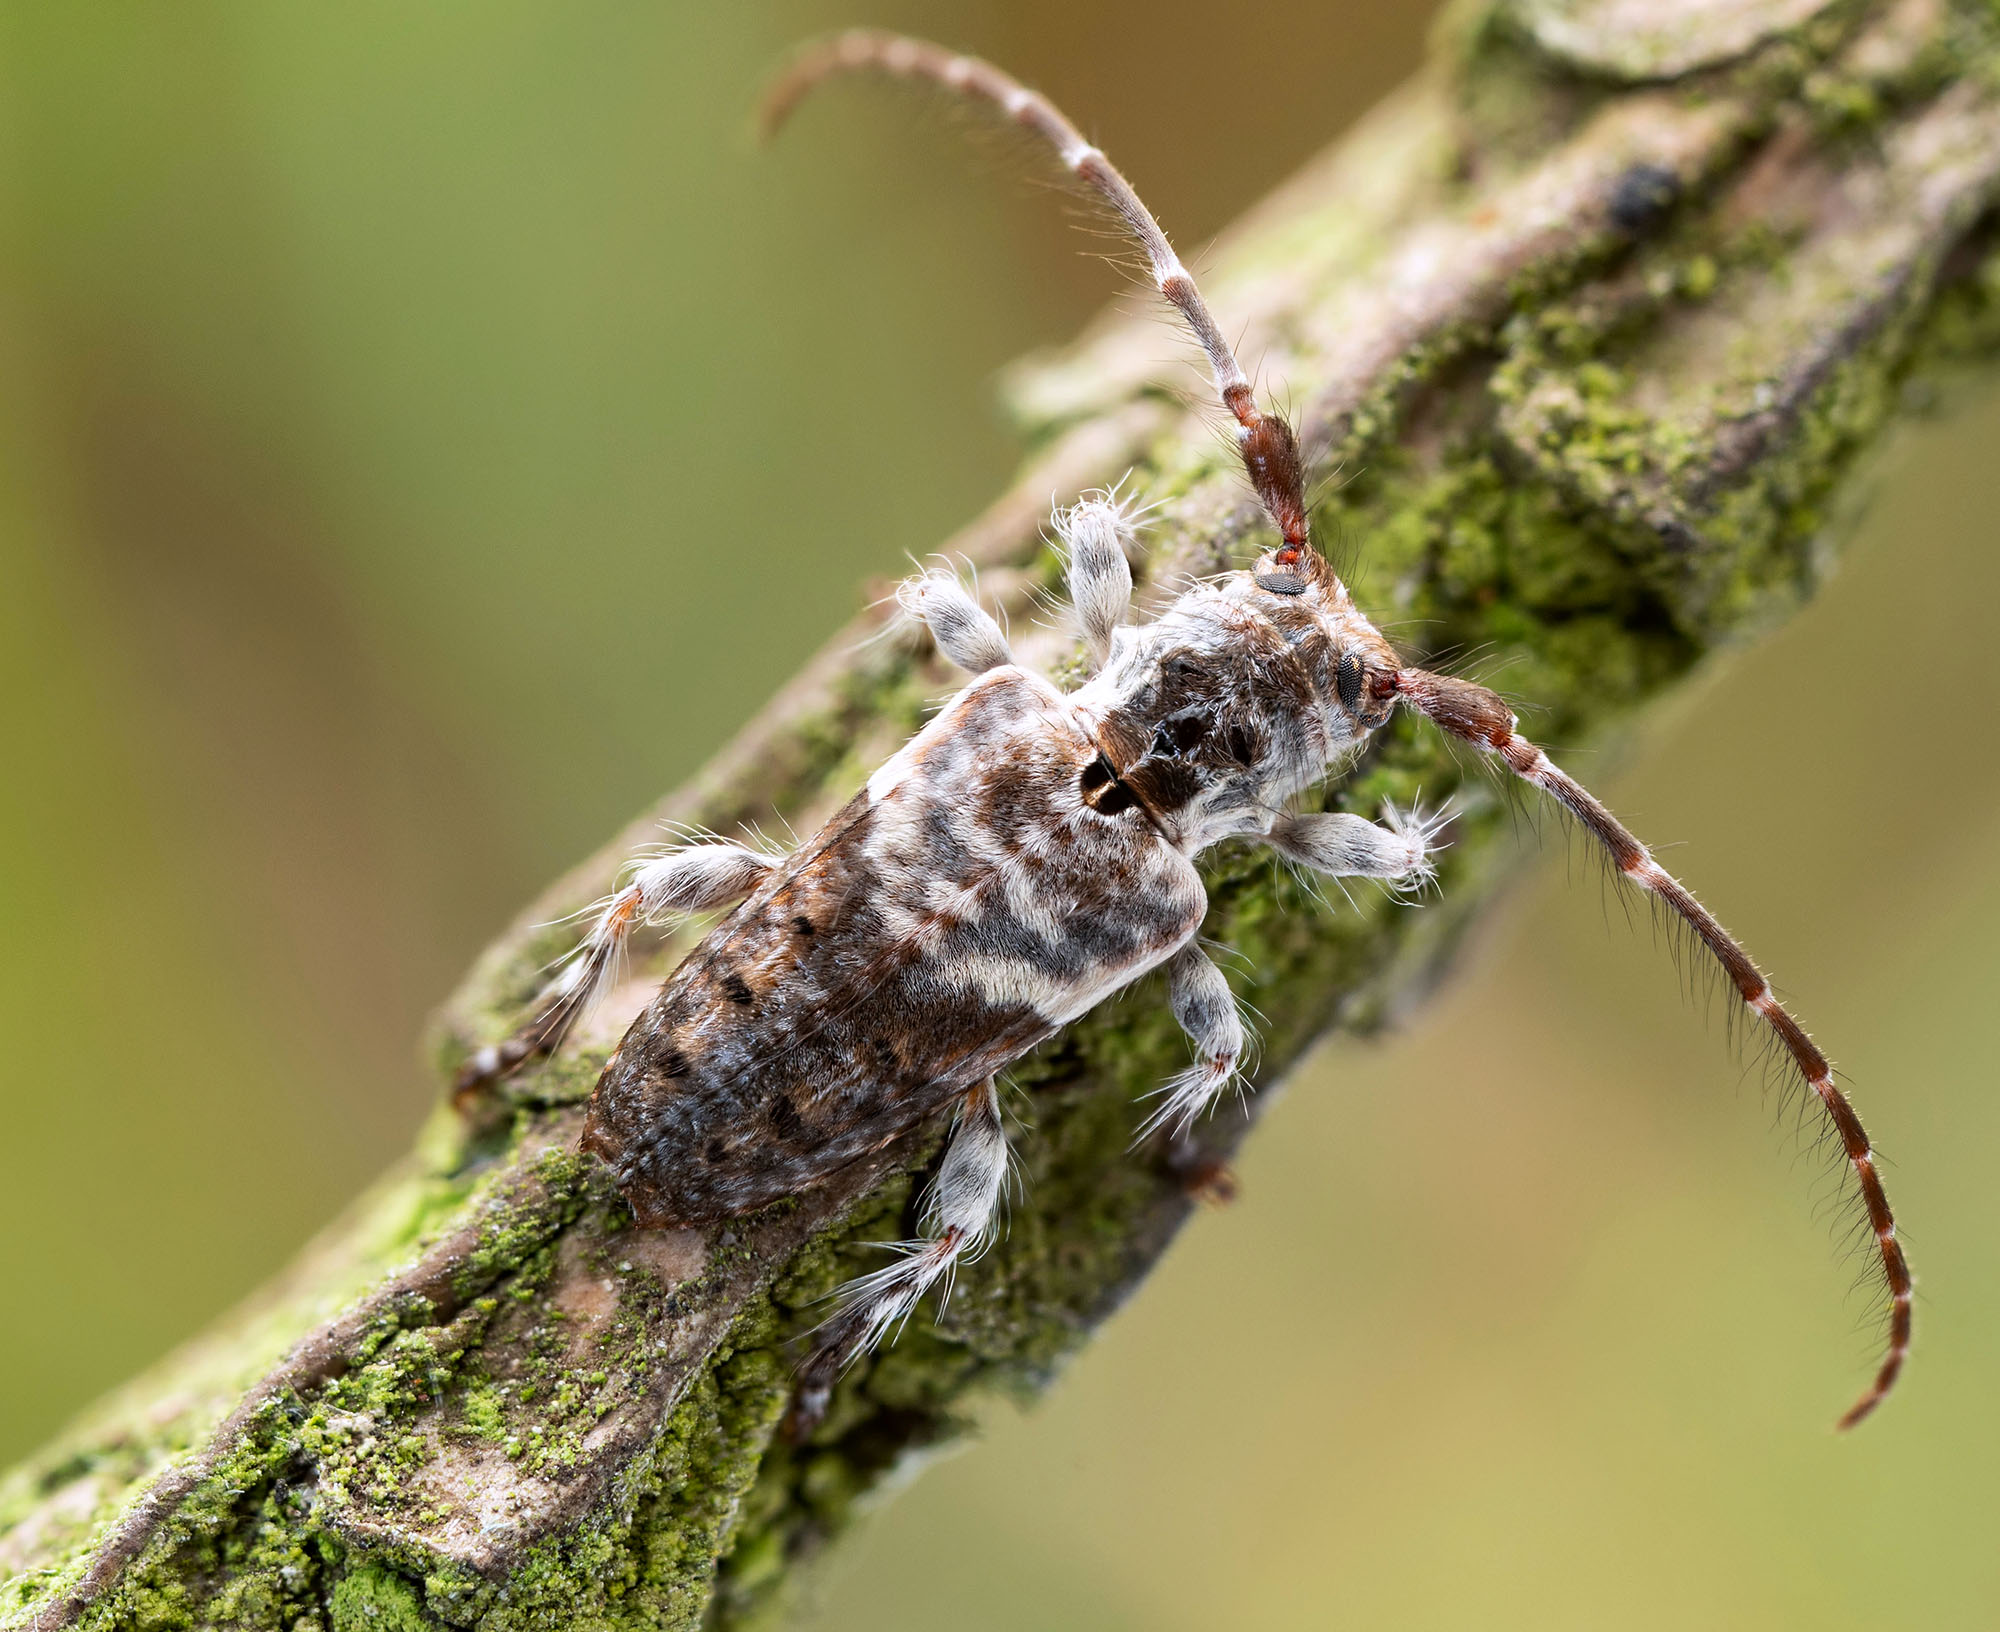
[786,1078,1008,1440]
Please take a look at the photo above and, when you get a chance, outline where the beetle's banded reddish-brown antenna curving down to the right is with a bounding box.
[1396,668,1914,1428]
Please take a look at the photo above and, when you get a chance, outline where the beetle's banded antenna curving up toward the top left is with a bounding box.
[760,28,1312,566]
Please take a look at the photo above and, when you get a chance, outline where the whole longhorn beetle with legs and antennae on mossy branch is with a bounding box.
[458,30,1912,1428]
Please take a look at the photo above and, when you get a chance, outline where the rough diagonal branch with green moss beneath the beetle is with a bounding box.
[0,0,2000,1632]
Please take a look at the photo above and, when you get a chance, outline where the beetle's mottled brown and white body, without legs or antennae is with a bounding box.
[584,552,1422,1224]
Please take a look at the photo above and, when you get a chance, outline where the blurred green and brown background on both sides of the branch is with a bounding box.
[0,0,2000,1632]
